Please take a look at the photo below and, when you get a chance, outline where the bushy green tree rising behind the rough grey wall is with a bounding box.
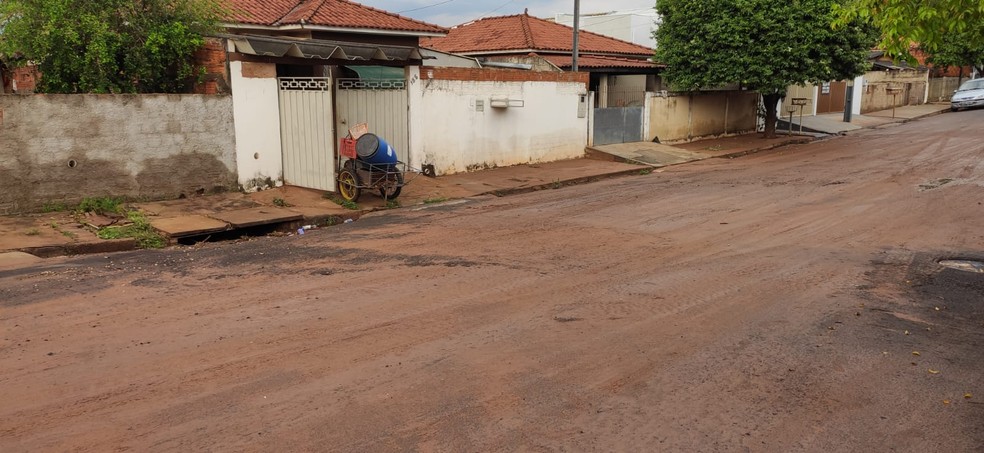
[0,0,221,93]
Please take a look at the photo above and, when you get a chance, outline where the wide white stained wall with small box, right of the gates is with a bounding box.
[409,77,588,175]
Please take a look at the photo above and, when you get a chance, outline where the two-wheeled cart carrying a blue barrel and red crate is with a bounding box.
[337,133,408,202]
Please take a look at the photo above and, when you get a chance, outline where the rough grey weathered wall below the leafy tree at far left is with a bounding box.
[0,95,238,214]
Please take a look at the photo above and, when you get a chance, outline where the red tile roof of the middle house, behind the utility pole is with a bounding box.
[420,14,653,57]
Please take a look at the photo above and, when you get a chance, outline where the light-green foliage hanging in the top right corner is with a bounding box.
[835,0,984,62]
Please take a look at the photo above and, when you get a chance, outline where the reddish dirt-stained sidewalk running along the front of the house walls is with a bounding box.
[0,99,948,262]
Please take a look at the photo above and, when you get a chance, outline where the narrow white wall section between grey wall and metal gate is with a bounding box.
[229,61,283,191]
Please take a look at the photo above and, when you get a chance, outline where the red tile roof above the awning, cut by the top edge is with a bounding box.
[226,0,447,33]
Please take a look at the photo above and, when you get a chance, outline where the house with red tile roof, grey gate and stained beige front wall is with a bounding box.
[421,13,758,145]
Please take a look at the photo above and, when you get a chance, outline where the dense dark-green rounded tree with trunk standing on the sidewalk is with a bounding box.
[654,0,875,138]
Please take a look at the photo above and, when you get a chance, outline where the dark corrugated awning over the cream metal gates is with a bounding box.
[221,35,424,62]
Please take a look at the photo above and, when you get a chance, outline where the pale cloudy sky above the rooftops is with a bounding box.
[355,0,656,27]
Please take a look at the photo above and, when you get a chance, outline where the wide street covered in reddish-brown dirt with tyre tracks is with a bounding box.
[0,110,984,452]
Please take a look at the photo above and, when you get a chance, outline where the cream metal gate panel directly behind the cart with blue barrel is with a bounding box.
[335,79,410,164]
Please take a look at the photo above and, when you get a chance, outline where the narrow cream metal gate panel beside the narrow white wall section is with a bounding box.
[279,77,335,191]
